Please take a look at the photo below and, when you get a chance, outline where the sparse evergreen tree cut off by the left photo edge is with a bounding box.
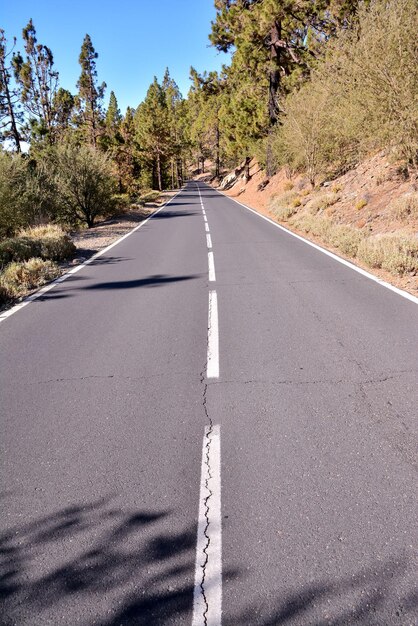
[0,29,22,152]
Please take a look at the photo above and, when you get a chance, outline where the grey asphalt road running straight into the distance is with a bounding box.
[0,182,418,626]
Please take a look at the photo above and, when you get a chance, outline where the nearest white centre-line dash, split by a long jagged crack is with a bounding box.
[192,424,222,626]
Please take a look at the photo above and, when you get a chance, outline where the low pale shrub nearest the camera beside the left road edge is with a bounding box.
[0,258,61,299]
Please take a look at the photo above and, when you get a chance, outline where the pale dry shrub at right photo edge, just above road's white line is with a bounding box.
[358,234,418,275]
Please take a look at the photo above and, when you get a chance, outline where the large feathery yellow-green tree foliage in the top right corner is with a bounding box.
[275,0,418,178]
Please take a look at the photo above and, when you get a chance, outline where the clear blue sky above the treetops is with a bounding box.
[0,0,229,112]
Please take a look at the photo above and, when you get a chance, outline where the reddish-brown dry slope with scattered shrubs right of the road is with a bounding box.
[206,152,418,295]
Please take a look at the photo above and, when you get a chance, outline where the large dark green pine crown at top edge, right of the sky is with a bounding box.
[210,0,358,126]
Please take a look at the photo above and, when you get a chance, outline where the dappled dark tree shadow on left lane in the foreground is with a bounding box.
[0,498,201,626]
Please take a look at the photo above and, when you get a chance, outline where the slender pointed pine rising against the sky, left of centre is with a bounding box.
[77,34,106,147]
